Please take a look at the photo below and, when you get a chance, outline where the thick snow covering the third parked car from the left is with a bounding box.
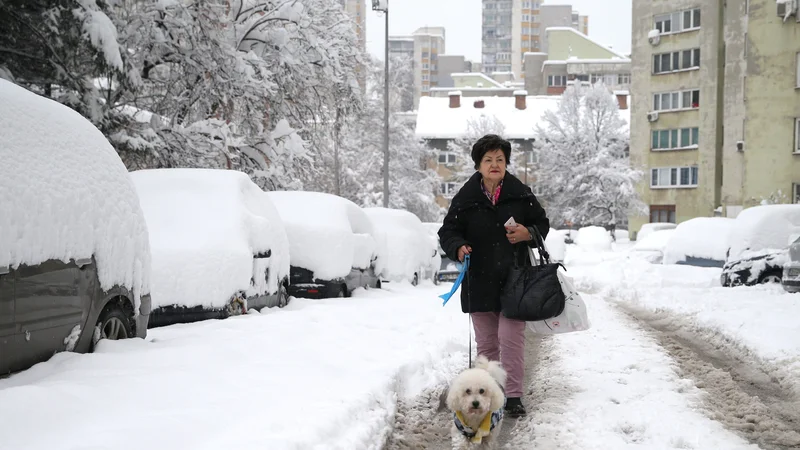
[267,191,376,280]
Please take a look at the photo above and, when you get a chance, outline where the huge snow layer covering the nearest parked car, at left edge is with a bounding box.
[0,80,150,306]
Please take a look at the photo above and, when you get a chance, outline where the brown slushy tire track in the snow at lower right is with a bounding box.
[615,302,800,450]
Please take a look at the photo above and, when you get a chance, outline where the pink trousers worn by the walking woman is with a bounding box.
[471,312,525,397]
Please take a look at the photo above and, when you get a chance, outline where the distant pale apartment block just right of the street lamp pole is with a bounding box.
[389,27,445,109]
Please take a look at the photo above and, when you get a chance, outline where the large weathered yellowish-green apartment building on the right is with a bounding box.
[630,0,800,236]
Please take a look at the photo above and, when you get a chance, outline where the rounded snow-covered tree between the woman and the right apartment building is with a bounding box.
[536,83,646,226]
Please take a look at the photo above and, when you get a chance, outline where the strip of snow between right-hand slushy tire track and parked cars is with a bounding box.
[569,248,800,394]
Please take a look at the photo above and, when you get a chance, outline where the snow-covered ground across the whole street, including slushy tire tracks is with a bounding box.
[0,246,800,450]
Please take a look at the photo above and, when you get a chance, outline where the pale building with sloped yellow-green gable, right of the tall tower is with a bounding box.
[524,27,631,95]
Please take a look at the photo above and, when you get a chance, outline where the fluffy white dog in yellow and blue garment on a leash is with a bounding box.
[447,356,506,450]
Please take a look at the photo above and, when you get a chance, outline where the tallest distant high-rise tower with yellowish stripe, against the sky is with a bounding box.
[481,0,589,78]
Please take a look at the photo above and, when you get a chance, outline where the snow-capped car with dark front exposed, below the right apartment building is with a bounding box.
[720,205,800,287]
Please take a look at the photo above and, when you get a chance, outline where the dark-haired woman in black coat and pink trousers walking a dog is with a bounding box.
[439,134,550,417]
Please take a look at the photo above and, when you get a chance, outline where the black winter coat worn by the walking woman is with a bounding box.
[439,172,550,313]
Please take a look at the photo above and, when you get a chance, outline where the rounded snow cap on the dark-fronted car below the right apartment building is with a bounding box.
[728,205,800,260]
